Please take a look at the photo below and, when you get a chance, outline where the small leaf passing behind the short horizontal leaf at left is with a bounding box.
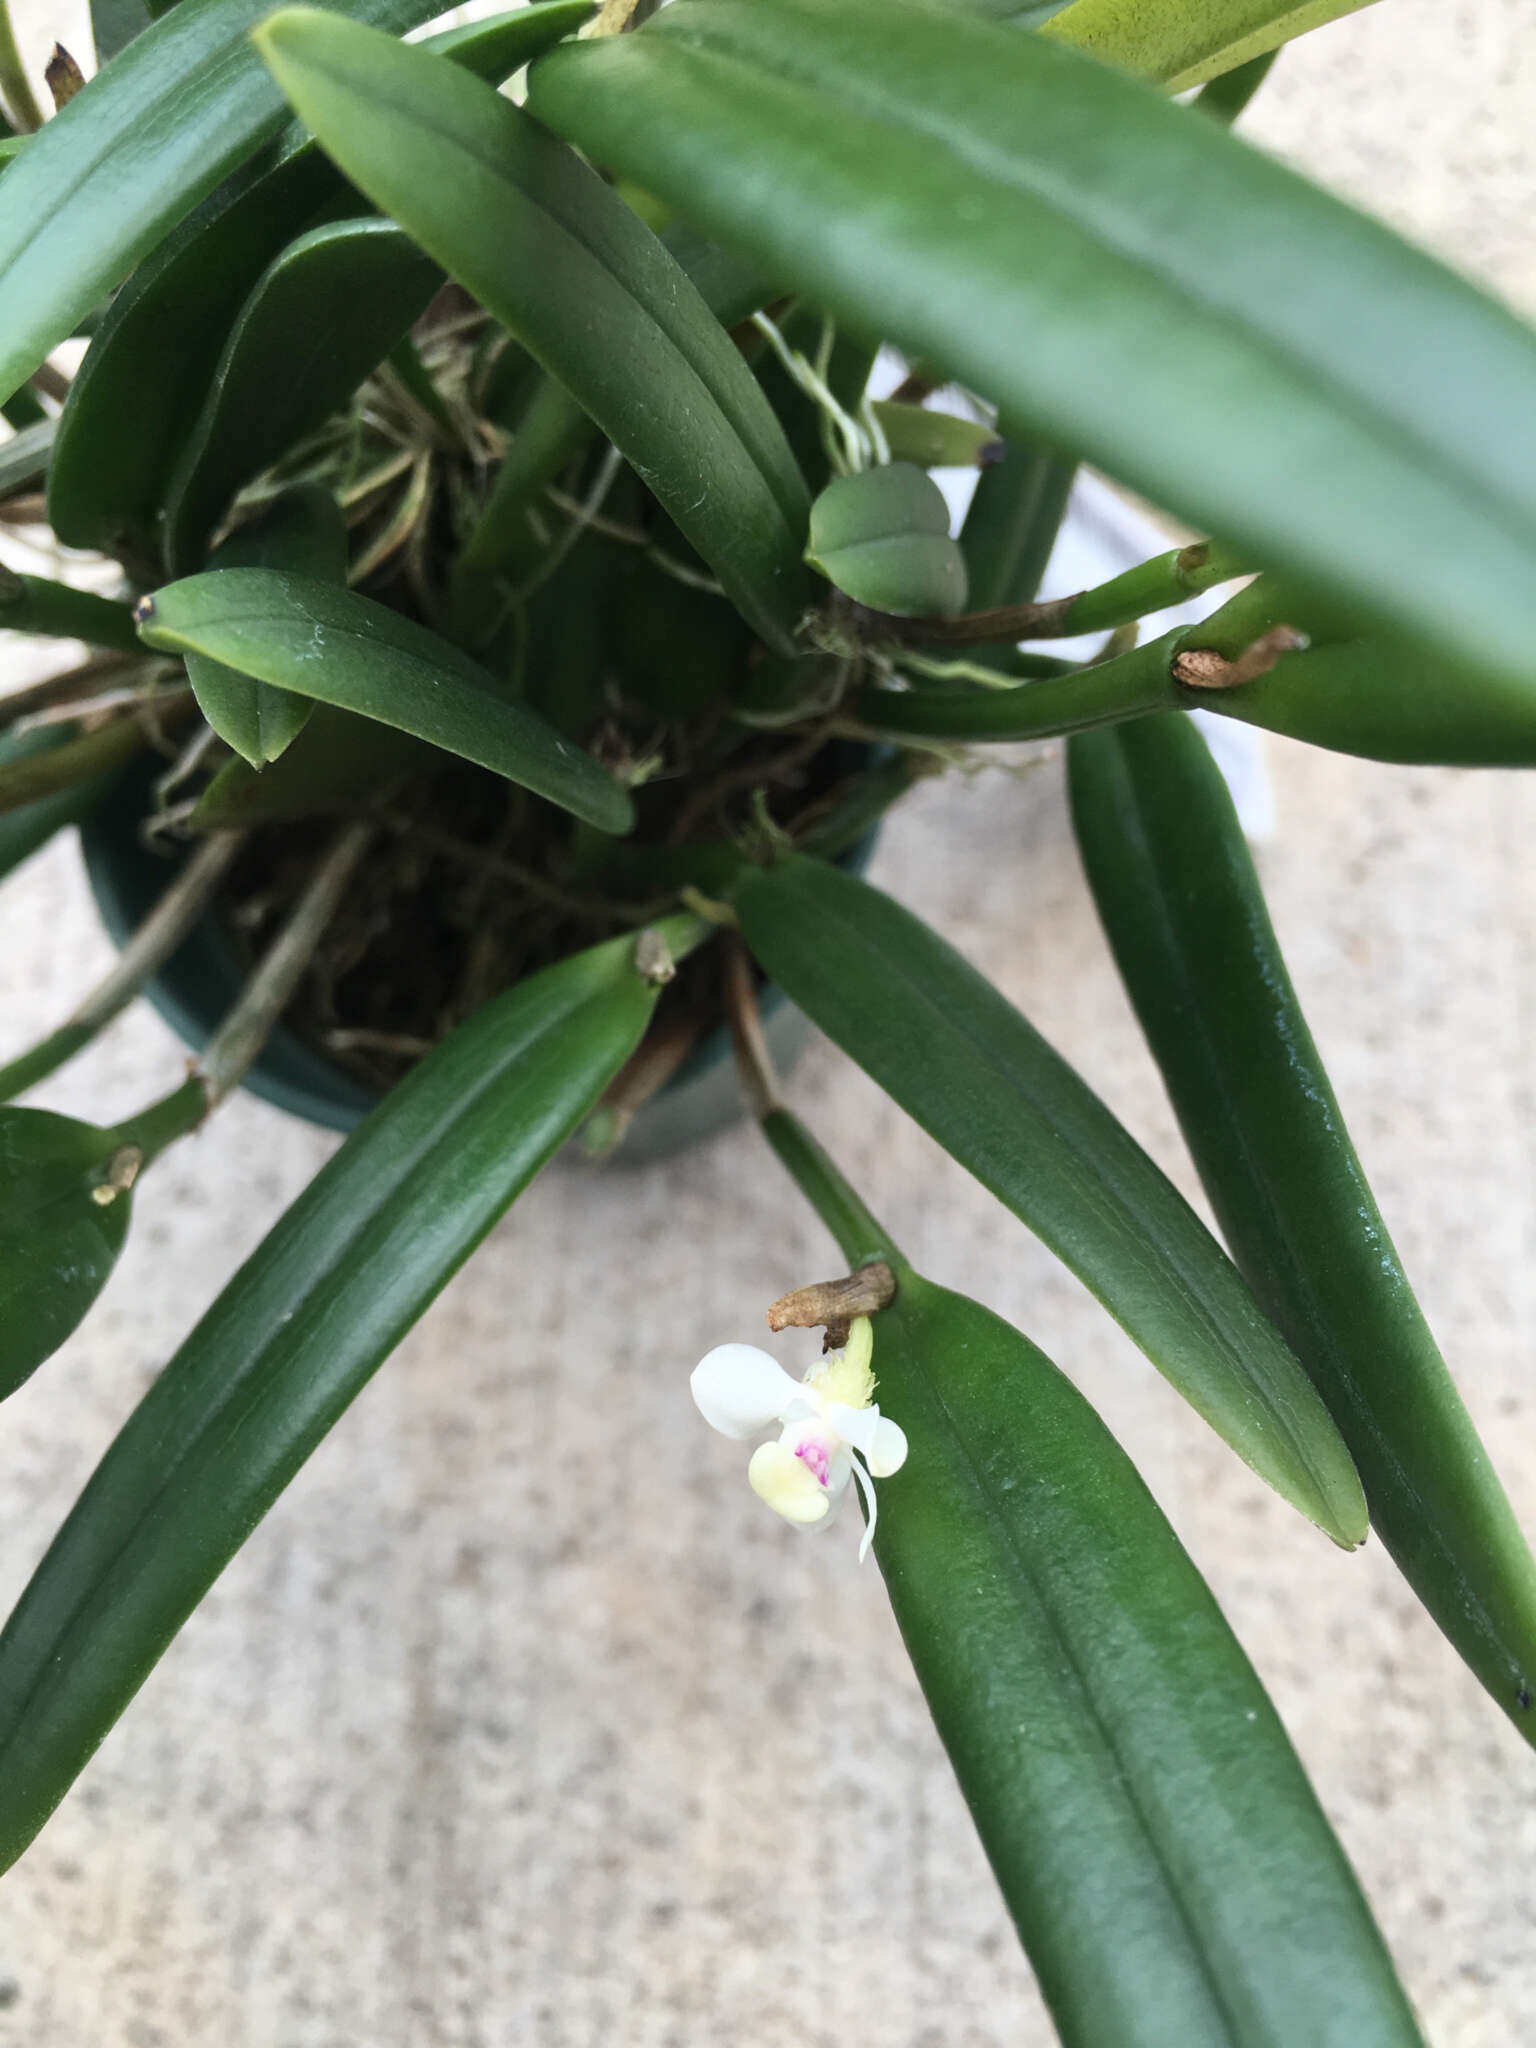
[186,483,346,768]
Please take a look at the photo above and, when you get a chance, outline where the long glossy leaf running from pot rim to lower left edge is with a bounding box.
[0,929,679,1868]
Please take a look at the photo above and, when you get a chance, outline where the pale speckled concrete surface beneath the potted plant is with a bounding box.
[0,0,1536,2048]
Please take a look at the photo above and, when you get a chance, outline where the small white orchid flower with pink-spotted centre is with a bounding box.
[688,1315,907,1563]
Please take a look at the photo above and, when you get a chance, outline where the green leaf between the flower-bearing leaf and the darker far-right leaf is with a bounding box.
[737,858,1366,1544]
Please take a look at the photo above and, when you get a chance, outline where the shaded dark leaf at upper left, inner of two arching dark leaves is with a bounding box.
[166,219,442,575]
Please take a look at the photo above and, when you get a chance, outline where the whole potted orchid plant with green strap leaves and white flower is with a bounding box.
[0,0,1536,2048]
